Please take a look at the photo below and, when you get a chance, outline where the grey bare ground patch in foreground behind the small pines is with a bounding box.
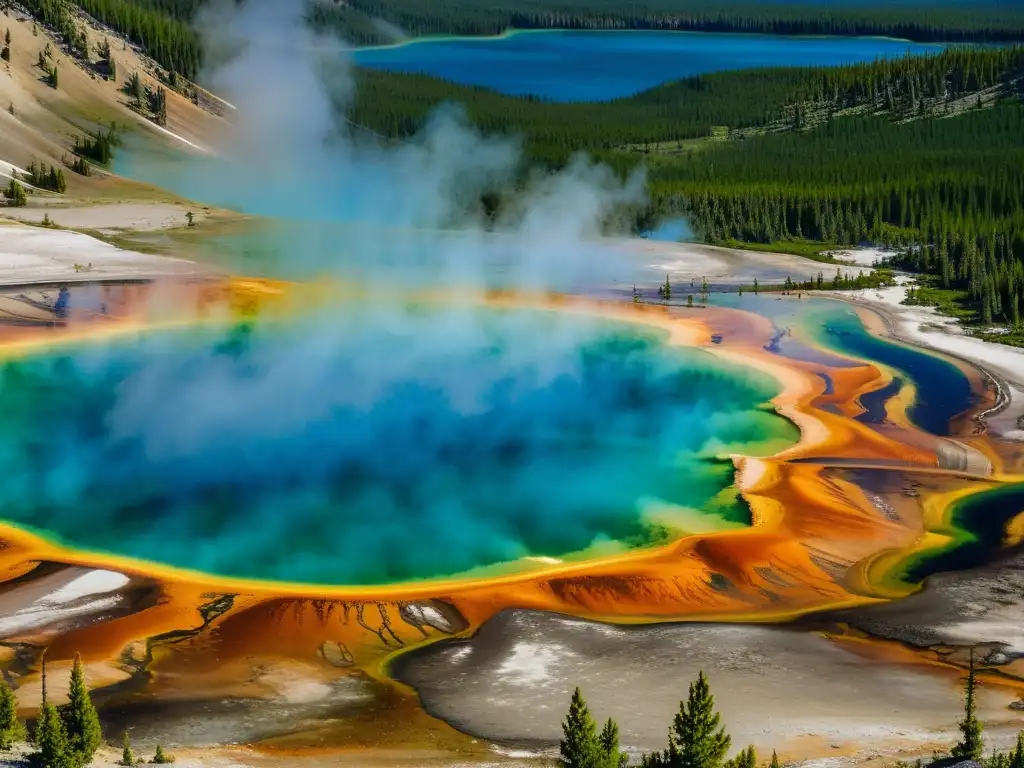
[398,610,1022,759]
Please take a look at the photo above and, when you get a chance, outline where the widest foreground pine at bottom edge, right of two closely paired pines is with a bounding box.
[668,672,732,768]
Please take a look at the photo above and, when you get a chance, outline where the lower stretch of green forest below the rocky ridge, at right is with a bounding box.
[651,101,1024,326]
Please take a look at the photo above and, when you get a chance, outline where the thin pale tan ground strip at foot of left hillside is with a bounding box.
[0,198,210,231]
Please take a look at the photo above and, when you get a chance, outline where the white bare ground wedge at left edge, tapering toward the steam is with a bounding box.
[0,226,212,286]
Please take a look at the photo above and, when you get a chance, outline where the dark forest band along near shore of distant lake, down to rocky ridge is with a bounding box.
[347,46,1024,159]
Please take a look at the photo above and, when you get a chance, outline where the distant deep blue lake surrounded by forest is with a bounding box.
[355,31,942,101]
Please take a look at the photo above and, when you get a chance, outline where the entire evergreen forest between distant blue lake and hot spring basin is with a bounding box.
[349,47,1024,325]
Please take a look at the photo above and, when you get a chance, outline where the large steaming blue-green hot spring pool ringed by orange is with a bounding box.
[0,306,798,586]
